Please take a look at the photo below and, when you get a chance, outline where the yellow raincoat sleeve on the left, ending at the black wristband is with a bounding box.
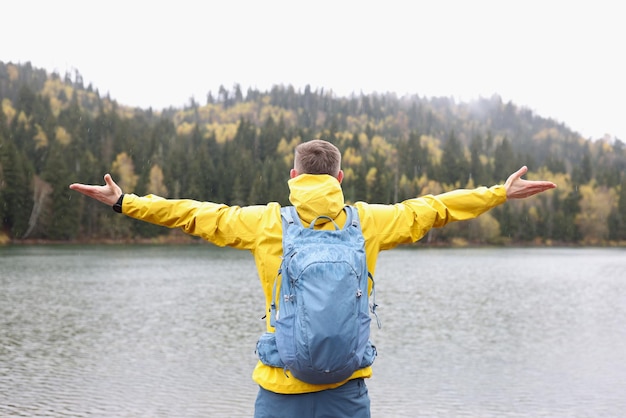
[122,194,278,249]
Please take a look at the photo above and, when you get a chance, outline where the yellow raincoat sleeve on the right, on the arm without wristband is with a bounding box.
[362,185,506,250]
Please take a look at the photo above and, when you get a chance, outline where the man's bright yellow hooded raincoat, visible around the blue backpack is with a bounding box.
[122,174,506,394]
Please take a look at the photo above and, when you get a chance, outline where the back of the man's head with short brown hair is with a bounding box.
[291,139,343,182]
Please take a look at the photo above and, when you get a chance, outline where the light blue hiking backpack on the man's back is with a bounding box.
[257,206,376,384]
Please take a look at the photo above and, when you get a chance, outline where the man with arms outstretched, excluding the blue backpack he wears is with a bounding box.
[70,140,556,418]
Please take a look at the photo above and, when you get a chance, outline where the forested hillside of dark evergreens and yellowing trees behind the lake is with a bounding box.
[0,62,626,245]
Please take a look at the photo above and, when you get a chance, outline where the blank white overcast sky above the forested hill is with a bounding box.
[0,0,626,140]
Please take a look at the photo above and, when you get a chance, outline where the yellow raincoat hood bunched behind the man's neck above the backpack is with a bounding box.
[288,174,345,223]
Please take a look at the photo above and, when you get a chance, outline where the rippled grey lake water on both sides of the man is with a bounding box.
[0,245,626,417]
